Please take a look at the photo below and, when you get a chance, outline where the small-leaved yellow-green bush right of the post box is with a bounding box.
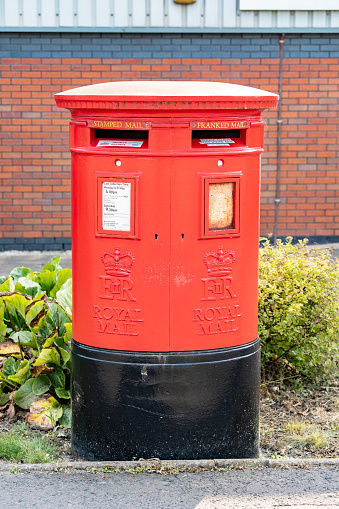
[259,237,339,378]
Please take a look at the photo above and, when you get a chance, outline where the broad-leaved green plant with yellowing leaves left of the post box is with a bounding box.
[0,256,72,429]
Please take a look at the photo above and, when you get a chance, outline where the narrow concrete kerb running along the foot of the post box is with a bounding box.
[0,458,339,474]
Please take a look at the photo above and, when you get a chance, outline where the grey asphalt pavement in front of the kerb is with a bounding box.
[0,467,339,509]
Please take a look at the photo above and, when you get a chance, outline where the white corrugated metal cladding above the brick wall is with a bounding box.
[0,0,339,32]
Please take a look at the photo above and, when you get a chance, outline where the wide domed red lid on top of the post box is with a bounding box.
[54,81,278,111]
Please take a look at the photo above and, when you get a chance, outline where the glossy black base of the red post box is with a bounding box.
[72,339,260,460]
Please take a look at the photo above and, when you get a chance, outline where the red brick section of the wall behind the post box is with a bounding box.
[0,58,339,242]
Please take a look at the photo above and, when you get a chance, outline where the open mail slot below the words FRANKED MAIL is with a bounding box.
[192,129,245,149]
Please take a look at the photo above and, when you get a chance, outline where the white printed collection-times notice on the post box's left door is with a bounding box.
[102,182,131,232]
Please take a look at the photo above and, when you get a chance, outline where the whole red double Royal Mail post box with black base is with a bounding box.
[55,81,278,460]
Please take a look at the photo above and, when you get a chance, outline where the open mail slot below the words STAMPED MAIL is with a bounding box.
[92,129,148,149]
